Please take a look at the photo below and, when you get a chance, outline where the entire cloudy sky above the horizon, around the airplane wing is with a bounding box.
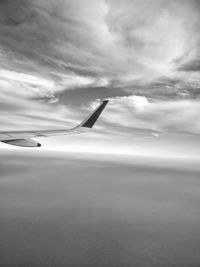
[0,0,200,157]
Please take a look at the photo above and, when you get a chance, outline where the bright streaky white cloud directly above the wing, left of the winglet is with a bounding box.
[0,71,76,131]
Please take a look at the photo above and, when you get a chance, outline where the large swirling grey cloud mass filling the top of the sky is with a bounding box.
[0,0,199,89]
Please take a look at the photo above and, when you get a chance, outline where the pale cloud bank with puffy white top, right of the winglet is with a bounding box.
[104,96,200,135]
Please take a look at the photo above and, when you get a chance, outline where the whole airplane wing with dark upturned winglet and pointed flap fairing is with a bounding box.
[0,100,108,147]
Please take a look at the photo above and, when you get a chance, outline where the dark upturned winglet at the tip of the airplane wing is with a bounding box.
[80,100,109,128]
